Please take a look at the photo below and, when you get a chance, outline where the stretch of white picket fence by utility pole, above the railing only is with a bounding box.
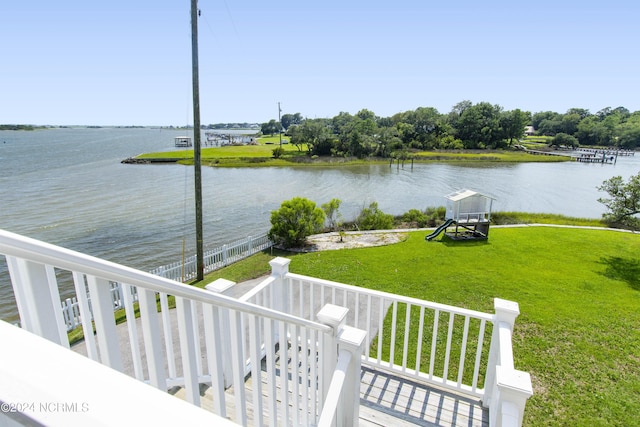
[151,234,273,282]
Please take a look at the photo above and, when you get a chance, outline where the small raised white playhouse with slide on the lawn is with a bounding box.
[425,189,494,241]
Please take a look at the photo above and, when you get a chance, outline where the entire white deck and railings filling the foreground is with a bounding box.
[0,230,532,426]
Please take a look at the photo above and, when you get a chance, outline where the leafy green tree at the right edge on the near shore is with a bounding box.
[598,173,640,230]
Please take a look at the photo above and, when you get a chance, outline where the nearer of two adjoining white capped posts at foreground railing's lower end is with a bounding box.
[338,325,367,426]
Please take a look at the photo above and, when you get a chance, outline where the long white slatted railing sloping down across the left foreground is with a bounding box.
[0,230,360,426]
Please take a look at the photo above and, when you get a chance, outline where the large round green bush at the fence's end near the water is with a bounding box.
[269,197,324,248]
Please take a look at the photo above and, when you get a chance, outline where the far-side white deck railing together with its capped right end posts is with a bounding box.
[243,258,532,426]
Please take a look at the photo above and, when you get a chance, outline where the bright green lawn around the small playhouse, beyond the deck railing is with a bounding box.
[208,227,640,426]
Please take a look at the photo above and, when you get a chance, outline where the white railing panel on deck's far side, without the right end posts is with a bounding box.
[242,266,494,397]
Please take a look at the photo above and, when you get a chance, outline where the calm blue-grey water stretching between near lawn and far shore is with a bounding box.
[0,129,640,320]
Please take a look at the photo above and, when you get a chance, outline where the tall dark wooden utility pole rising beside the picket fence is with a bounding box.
[191,0,204,280]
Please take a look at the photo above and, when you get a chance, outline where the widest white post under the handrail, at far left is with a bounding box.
[6,256,69,348]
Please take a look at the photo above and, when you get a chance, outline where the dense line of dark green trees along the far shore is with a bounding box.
[261,101,640,157]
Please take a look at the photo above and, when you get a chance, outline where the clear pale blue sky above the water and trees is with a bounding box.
[0,0,640,126]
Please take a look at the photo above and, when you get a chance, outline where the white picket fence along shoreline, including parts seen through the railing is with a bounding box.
[62,233,273,331]
